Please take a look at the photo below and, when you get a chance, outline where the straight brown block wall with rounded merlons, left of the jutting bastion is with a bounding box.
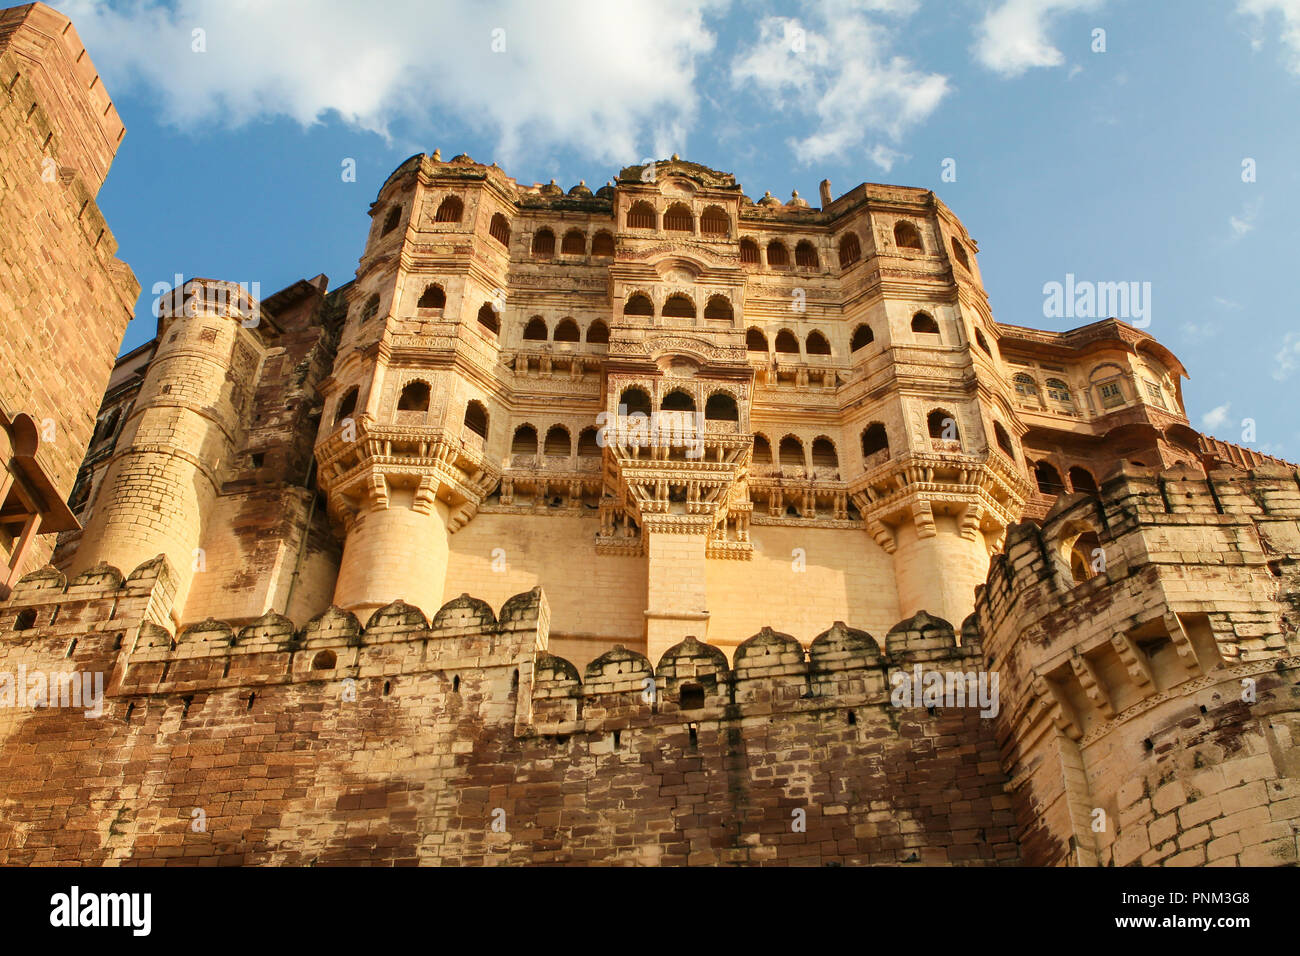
[0,561,1018,865]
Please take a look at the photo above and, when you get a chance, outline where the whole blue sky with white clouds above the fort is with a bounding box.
[55,0,1300,460]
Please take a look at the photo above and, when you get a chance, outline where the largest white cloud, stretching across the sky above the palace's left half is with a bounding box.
[59,0,718,163]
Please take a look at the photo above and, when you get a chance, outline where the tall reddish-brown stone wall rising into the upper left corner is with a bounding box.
[0,4,139,568]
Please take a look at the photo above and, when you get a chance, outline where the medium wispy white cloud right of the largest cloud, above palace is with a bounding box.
[731,0,949,170]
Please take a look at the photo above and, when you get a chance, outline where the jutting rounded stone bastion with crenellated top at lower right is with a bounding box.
[976,466,1300,865]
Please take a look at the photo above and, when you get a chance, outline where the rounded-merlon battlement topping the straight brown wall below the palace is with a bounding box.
[0,555,983,734]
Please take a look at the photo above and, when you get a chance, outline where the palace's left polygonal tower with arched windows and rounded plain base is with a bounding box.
[317,156,508,617]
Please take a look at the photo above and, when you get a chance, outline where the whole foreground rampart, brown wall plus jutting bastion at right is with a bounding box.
[0,470,1300,866]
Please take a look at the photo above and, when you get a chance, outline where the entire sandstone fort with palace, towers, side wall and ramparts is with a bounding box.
[0,4,1300,866]
